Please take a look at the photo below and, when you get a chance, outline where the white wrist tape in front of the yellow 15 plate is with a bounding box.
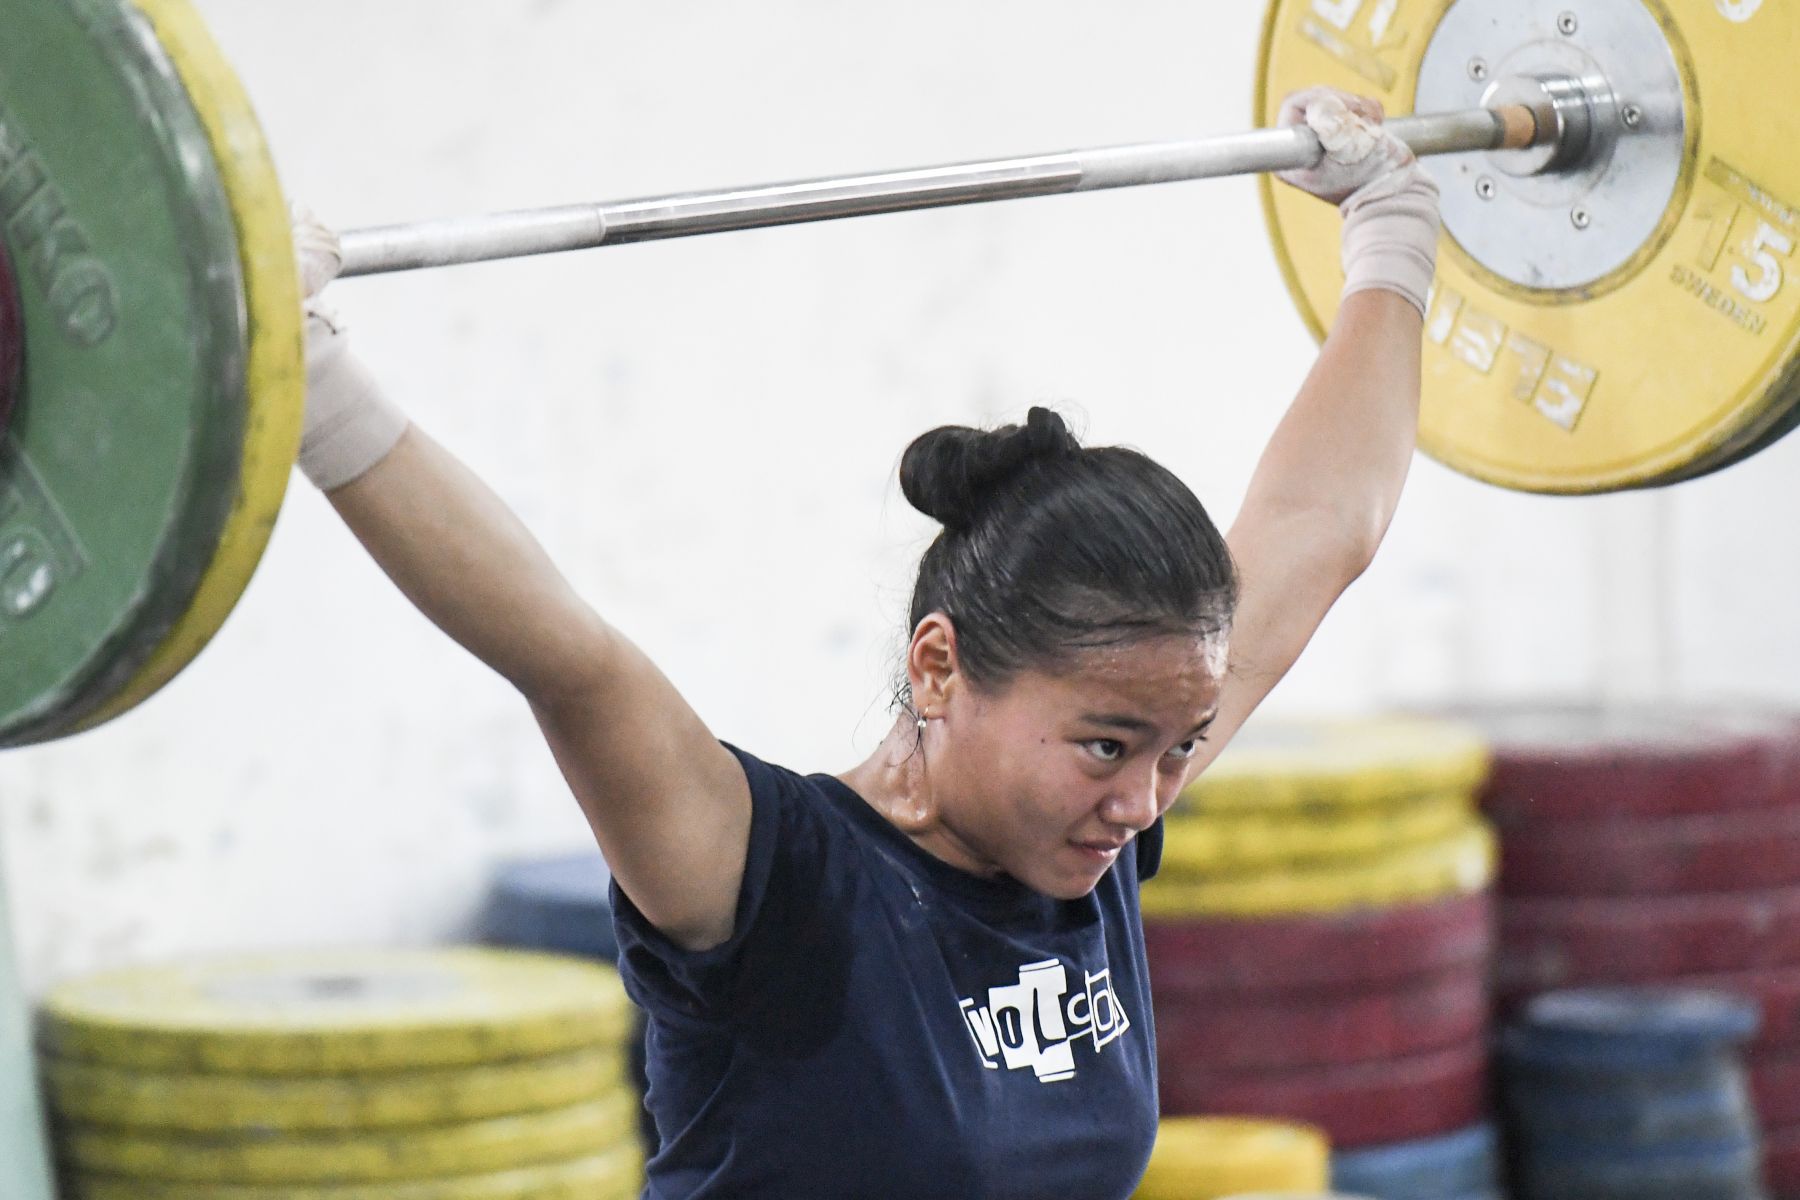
[1337,162,1440,317]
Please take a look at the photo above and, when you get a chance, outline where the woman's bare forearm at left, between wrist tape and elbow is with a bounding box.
[328,426,610,703]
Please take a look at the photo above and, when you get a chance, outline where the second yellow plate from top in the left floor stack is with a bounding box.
[43,1049,630,1133]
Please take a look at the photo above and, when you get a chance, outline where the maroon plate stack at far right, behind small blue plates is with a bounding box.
[1467,707,1800,1198]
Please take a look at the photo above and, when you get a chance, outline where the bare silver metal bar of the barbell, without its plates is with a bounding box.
[342,106,1552,275]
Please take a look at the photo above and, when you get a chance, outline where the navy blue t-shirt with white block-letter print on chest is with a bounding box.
[614,748,1161,1200]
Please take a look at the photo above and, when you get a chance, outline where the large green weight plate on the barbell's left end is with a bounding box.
[0,0,247,745]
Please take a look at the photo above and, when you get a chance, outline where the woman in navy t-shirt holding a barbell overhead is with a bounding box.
[299,90,1438,1200]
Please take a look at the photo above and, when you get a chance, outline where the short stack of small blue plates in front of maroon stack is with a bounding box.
[1501,988,1768,1200]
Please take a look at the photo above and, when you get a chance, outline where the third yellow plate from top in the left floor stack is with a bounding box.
[59,1096,637,1184]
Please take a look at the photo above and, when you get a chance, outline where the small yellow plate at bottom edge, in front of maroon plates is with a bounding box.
[1132,1117,1330,1200]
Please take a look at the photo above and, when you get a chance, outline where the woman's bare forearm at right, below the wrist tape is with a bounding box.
[1244,290,1422,570]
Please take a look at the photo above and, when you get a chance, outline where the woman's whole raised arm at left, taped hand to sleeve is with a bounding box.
[299,228,751,950]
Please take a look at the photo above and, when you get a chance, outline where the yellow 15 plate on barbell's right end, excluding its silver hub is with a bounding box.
[1258,0,1800,493]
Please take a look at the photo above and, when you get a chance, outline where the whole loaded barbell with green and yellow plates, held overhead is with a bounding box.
[0,0,1800,745]
